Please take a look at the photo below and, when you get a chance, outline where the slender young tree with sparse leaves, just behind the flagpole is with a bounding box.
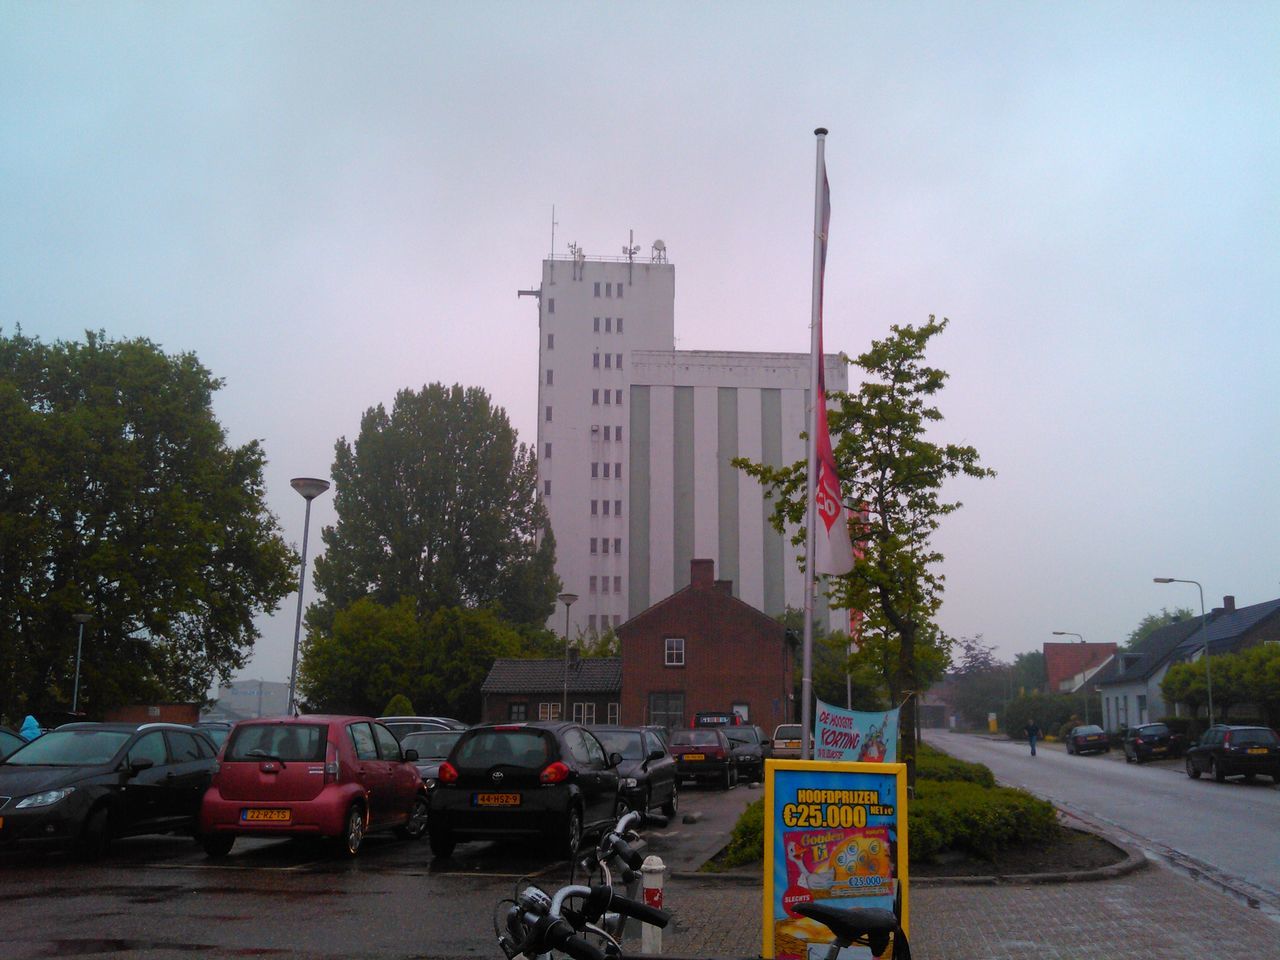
[735,316,995,781]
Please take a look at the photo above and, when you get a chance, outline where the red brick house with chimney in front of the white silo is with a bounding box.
[617,559,795,735]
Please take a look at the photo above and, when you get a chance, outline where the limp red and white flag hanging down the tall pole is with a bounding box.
[813,164,854,576]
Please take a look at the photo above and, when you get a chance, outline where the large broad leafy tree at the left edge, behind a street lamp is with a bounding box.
[0,330,297,718]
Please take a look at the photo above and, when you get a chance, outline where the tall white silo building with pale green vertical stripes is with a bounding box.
[538,251,849,636]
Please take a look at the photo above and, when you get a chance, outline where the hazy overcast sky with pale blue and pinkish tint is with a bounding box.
[0,0,1280,680]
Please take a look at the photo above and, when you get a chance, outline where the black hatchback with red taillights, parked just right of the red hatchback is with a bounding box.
[428,721,622,858]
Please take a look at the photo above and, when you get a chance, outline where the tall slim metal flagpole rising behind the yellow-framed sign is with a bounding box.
[800,127,827,760]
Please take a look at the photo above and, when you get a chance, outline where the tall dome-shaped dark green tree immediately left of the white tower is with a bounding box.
[307,384,559,632]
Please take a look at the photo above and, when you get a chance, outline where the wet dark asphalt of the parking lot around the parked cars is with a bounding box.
[0,786,760,960]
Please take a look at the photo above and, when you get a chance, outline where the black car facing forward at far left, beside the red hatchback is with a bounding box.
[0,723,218,858]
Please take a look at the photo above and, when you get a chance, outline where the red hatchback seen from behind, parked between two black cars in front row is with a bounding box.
[200,717,428,856]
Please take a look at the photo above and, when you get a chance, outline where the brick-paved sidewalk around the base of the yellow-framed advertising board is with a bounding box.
[655,864,1280,960]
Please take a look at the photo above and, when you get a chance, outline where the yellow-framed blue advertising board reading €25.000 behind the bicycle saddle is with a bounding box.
[762,760,908,960]
